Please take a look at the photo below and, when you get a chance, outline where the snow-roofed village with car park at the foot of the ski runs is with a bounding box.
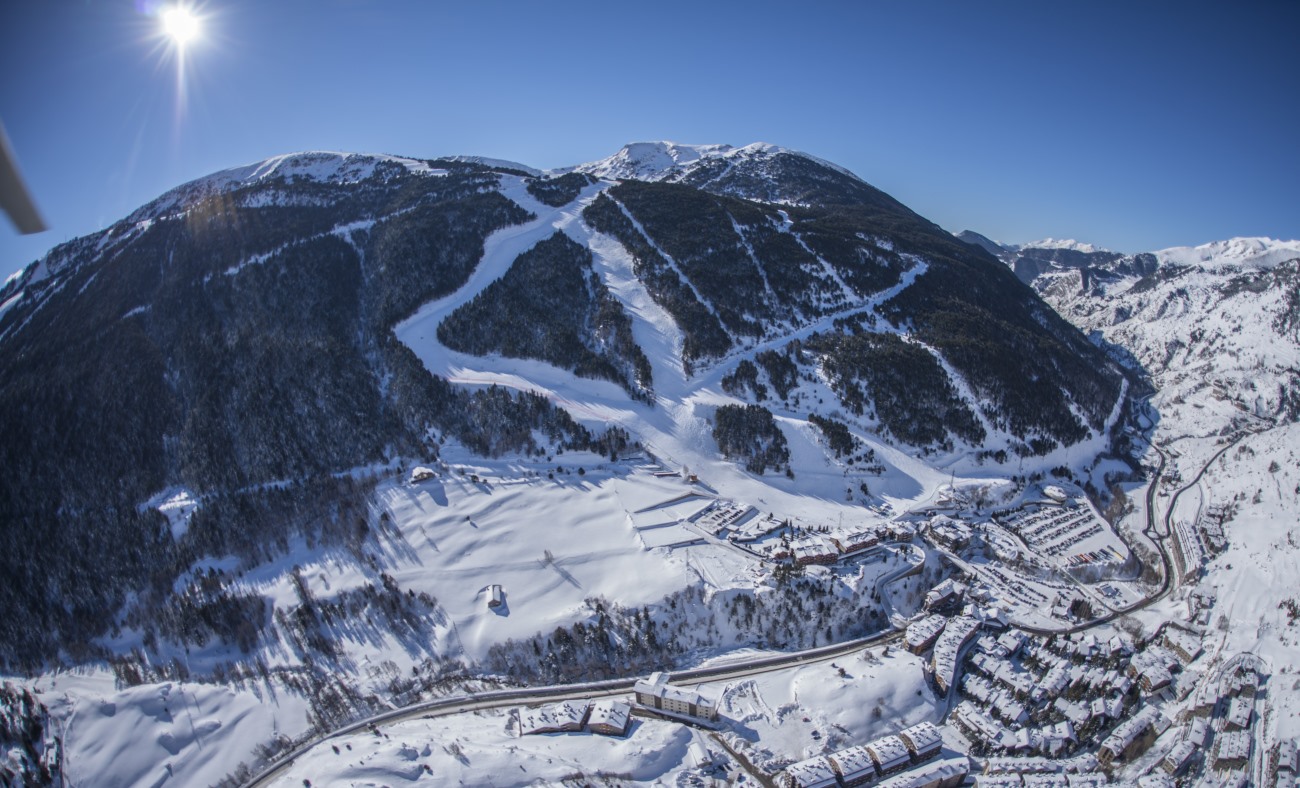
[480,465,1297,788]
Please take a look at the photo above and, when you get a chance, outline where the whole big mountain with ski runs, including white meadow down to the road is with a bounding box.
[0,143,1154,784]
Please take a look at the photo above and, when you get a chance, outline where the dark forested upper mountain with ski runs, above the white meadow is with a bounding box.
[0,144,1127,664]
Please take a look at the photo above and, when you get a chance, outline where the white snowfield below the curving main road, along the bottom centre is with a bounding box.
[261,648,937,788]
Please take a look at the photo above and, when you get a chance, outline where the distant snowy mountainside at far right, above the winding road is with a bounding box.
[1034,238,1300,433]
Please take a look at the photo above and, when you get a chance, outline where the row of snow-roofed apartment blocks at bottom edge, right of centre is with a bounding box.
[776,723,966,788]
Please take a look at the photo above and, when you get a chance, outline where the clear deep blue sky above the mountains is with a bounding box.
[0,0,1300,272]
